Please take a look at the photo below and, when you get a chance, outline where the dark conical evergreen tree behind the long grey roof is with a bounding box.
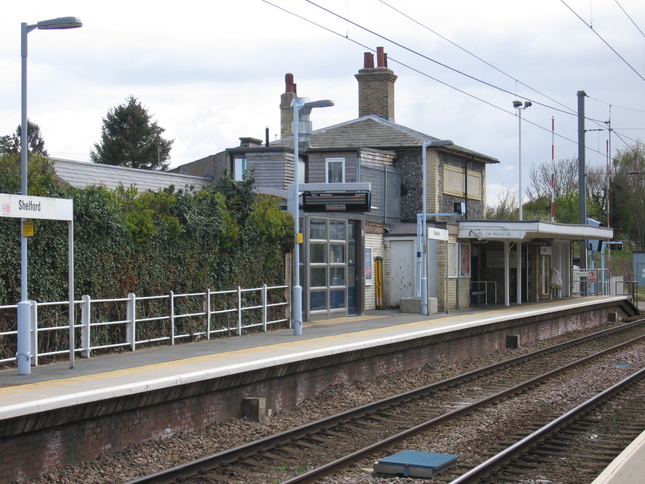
[90,96,174,170]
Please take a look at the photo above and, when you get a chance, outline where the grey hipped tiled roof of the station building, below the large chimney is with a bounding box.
[271,114,499,163]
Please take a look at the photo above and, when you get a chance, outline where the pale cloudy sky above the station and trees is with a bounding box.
[0,0,645,205]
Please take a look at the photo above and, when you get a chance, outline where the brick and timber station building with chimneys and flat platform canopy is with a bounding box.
[173,48,612,321]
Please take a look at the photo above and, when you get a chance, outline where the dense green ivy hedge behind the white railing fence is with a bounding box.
[0,155,294,346]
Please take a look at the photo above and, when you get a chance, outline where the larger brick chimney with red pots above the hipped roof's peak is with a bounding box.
[356,47,397,122]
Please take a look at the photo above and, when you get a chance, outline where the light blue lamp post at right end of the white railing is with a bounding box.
[291,97,334,336]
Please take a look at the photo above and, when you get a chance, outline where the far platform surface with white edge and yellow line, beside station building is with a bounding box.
[0,296,636,420]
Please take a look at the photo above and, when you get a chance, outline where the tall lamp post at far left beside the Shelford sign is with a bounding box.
[16,17,83,375]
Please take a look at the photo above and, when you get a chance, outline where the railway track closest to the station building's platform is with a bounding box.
[124,321,645,483]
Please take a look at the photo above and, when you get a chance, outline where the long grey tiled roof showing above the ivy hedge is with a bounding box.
[52,158,211,191]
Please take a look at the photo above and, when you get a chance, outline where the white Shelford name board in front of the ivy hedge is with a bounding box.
[0,193,74,222]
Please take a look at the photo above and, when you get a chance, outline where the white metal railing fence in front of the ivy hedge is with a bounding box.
[0,284,290,366]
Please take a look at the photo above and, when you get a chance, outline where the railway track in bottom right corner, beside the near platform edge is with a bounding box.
[452,369,645,484]
